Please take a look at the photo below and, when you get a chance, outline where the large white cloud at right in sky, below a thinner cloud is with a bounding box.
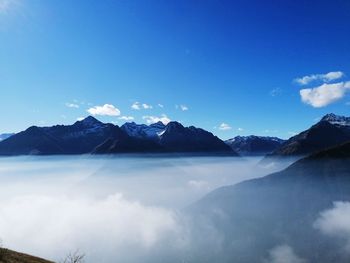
[300,81,350,108]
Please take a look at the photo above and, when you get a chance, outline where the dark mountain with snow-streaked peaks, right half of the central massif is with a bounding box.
[95,122,237,155]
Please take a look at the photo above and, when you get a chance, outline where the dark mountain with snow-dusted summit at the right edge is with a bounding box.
[269,114,350,157]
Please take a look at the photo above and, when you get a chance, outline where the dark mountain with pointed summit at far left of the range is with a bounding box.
[0,117,124,155]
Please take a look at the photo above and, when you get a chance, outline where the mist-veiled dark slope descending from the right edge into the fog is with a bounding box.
[192,143,350,262]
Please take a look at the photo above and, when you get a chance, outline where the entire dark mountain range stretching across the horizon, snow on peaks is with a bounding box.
[0,113,350,158]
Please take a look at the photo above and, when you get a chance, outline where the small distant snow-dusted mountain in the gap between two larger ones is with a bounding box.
[225,135,285,155]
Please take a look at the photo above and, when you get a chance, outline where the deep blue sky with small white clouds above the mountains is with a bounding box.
[0,0,350,138]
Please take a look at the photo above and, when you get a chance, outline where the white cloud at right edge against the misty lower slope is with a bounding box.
[314,202,350,253]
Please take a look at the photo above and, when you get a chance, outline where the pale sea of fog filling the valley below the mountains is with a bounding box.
[0,155,287,262]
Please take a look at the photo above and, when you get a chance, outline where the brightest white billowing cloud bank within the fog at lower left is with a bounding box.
[0,194,179,262]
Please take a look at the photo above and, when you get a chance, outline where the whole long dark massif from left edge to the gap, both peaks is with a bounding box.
[0,116,237,155]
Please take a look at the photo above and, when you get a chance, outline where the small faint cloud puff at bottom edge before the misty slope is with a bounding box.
[265,245,306,263]
